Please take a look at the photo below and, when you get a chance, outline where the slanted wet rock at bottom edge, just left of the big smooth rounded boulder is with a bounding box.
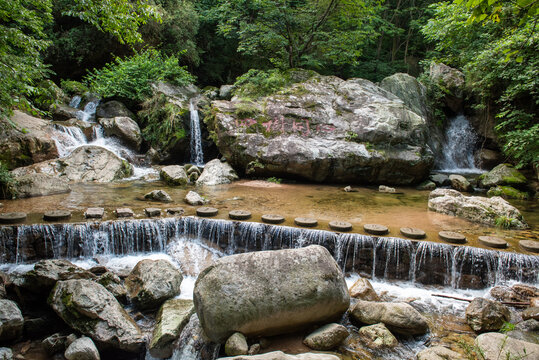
[148,299,195,359]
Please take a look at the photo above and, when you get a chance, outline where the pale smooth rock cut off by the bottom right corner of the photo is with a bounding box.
[475,332,539,360]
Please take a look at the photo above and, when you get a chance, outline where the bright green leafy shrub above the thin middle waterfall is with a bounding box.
[86,49,195,102]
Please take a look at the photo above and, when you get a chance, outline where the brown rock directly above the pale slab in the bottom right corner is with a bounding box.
[466,298,511,332]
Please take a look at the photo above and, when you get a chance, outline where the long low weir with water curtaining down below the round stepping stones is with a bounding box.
[0,217,539,289]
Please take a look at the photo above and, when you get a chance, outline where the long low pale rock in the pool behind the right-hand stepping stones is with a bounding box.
[428,189,528,229]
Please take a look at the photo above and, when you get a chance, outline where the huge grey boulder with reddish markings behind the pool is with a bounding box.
[205,73,433,184]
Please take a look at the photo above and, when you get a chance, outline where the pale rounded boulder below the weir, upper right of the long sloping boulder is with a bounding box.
[125,260,183,310]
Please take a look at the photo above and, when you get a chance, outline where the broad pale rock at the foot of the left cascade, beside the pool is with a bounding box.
[12,146,133,183]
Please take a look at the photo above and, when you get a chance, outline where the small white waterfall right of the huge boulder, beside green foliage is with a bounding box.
[437,115,480,173]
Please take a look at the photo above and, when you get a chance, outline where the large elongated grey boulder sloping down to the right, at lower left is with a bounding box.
[49,280,144,352]
